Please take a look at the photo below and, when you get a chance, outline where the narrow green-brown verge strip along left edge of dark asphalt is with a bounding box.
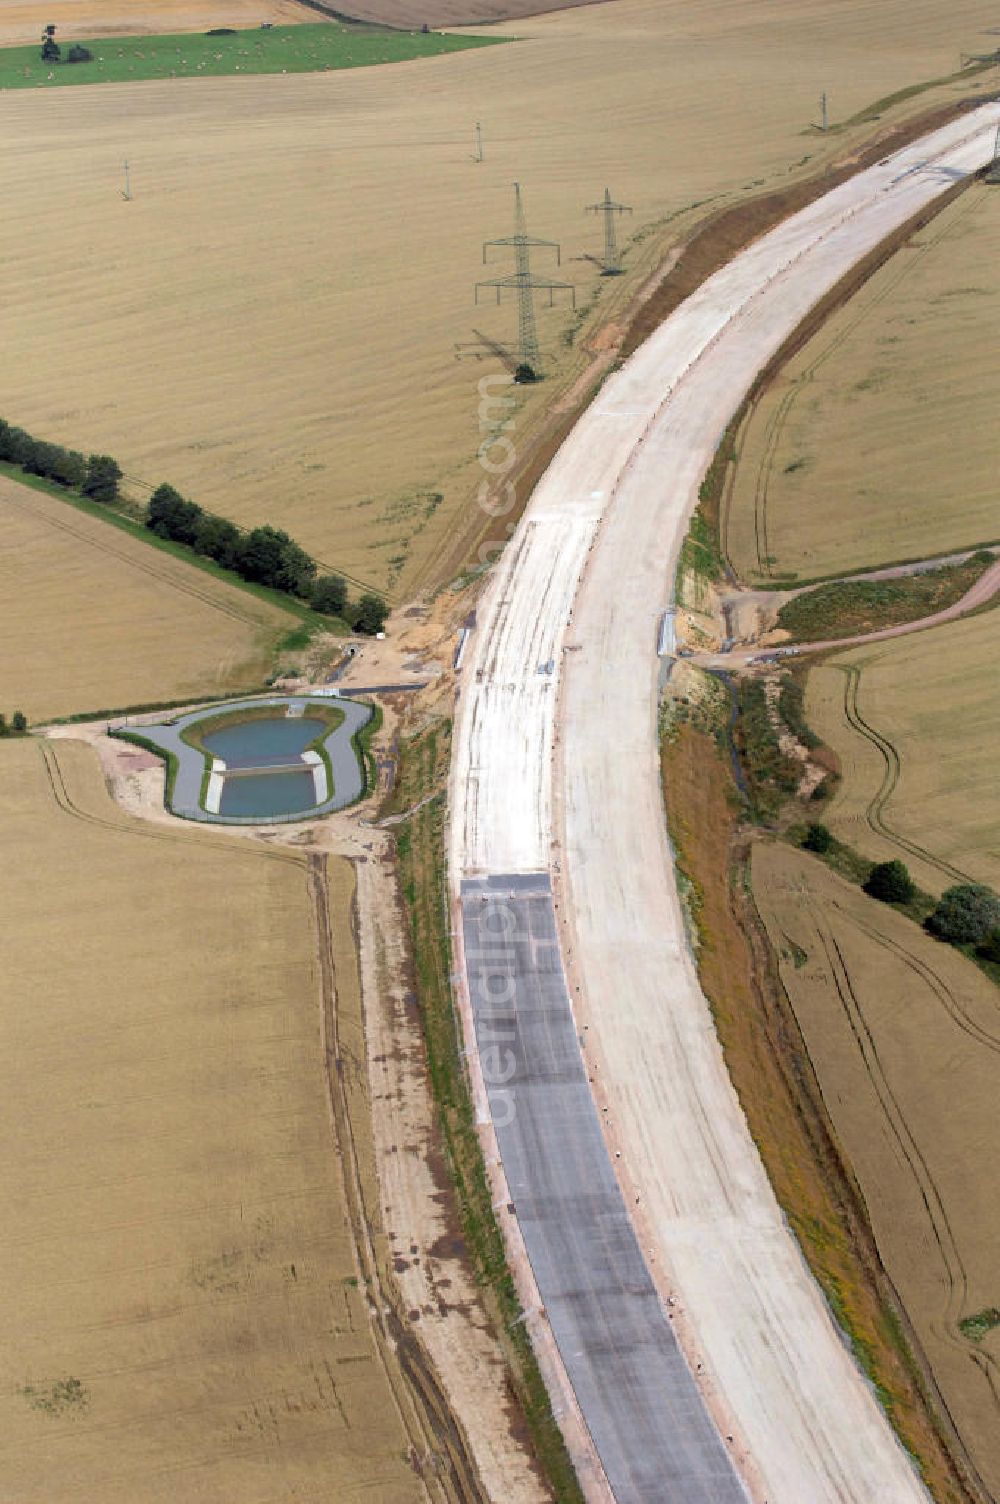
[385,720,583,1504]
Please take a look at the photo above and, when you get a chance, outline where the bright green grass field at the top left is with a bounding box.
[0,21,507,89]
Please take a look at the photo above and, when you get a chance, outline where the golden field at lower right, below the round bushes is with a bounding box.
[753,845,1000,1496]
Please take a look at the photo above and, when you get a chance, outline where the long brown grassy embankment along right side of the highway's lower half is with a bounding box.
[663,725,982,1504]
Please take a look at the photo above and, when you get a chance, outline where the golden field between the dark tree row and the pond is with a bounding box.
[0,475,298,720]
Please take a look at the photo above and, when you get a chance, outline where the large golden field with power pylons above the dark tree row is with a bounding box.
[0,0,995,599]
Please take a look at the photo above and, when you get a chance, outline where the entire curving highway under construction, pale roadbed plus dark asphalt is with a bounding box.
[448,104,1000,1504]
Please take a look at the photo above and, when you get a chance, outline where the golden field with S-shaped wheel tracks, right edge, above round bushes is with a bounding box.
[806,611,1000,893]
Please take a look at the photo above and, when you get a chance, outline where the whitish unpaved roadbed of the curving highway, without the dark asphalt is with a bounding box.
[450,104,1000,1504]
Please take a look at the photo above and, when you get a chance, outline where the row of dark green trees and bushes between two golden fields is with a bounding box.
[0,418,389,636]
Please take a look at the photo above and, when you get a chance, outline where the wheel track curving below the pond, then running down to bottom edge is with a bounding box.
[39,741,489,1504]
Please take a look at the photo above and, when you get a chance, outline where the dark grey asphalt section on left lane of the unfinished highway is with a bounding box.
[462,874,747,1504]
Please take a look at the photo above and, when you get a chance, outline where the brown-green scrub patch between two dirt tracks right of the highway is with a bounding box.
[777,549,995,642]
